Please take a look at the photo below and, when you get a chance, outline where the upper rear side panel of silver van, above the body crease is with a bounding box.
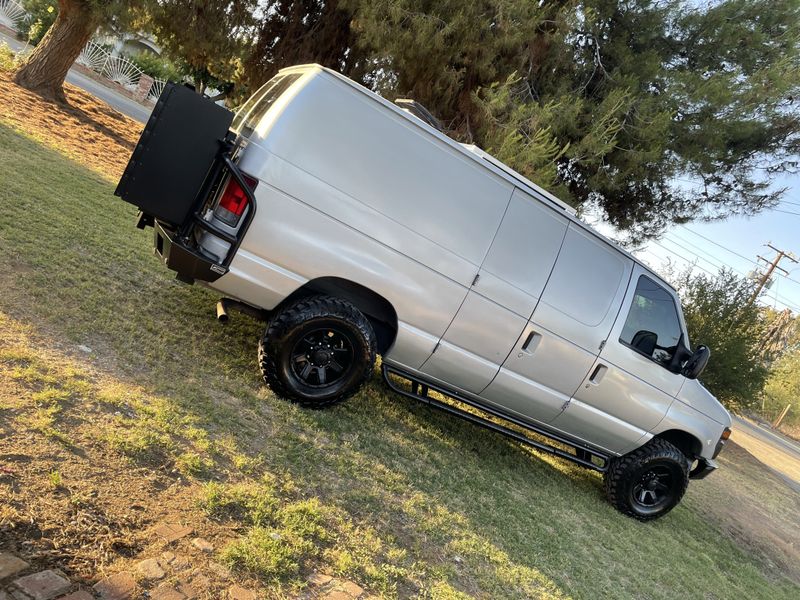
[245,72,513,264]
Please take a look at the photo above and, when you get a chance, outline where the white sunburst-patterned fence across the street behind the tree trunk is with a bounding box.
[0,0,167,100]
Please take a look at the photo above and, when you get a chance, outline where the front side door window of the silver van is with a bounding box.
[619,275,681,367]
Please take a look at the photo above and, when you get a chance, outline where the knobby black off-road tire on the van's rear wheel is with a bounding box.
[258,296,377,408]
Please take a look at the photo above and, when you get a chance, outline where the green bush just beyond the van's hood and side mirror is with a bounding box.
[677,270,768,410]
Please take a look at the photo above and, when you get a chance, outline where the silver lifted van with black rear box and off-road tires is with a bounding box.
[117,65,731,520]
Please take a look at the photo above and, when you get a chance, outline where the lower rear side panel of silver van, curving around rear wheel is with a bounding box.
[214,182,466,368]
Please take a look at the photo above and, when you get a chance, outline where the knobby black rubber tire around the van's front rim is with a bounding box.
[603,438,689,521]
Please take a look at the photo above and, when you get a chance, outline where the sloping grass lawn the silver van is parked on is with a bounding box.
[0,69,800,599]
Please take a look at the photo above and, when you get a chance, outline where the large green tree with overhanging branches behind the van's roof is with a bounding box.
[348,0,800,243]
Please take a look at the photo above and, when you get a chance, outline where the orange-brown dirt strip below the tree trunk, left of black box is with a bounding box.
[0,70,144,180]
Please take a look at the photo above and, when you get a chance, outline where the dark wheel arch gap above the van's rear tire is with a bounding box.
[281,277,398,354]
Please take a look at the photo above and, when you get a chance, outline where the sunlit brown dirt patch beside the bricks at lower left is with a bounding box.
[0,313,257,598]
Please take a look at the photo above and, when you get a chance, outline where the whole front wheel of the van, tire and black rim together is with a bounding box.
[603,438,689,521]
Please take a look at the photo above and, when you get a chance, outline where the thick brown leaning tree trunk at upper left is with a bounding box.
[14,0,97,102]
